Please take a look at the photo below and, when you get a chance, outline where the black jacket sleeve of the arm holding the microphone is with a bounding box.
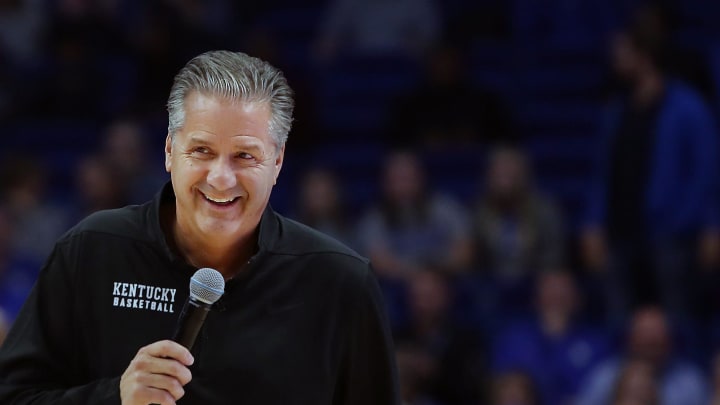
[0,241,120,404]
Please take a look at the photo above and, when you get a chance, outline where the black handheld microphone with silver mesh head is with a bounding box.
[172,267,225,350]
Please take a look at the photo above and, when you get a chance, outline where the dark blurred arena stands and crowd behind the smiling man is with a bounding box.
[0,0,720,405]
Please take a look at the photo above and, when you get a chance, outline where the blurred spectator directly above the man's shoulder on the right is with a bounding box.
[288,168,354,246]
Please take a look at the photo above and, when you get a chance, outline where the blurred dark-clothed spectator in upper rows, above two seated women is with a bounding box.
[388,44,515,148]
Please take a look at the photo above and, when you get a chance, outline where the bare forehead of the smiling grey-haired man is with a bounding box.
[179,91,272,142]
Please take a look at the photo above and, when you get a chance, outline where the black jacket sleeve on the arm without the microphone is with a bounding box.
[333,269,400,405]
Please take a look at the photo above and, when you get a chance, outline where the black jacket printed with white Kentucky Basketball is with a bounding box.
[0,185,399,405]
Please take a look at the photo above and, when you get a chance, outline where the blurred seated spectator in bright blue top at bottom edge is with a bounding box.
[493,271,608,405]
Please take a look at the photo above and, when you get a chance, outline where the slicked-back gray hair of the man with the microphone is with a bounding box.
[167,51,295,148]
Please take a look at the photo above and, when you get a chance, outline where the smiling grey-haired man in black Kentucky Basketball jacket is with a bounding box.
[0,51,399,405]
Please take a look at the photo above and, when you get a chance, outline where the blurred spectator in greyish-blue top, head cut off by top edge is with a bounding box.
[316,0,442,61]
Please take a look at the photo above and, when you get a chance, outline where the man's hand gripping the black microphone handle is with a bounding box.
[120,340,194,405]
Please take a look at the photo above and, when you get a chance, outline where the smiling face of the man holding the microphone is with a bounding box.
[165,92,285,241]
